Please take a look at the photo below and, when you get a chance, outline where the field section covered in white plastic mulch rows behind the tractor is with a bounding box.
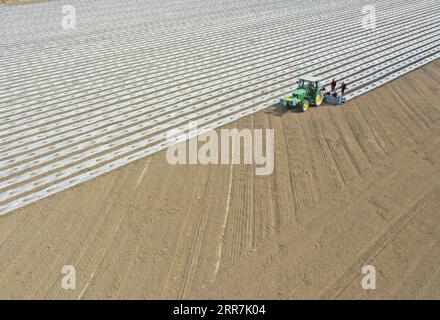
[0,0,440,214]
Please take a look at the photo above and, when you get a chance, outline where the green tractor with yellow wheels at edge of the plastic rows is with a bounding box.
[280,76,324,112]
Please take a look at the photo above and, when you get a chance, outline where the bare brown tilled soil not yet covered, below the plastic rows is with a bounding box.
[0,61,440,299]
